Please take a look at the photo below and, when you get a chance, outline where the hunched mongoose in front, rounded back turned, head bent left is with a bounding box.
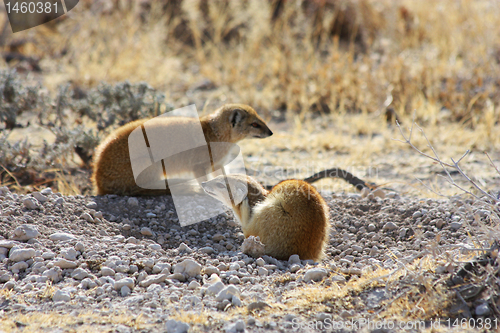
[201,175,329,261]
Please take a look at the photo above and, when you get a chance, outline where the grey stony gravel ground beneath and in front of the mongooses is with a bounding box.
[0,188,493,332]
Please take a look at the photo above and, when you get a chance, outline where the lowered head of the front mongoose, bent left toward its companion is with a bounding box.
[201,174,267,209]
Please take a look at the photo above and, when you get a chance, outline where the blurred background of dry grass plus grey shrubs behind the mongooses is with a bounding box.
[0,0,500,194]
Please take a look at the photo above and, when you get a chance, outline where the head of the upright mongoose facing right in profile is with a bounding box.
[216,104,273,142]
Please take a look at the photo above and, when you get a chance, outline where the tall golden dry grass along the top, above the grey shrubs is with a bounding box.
[0,0,500,120]
